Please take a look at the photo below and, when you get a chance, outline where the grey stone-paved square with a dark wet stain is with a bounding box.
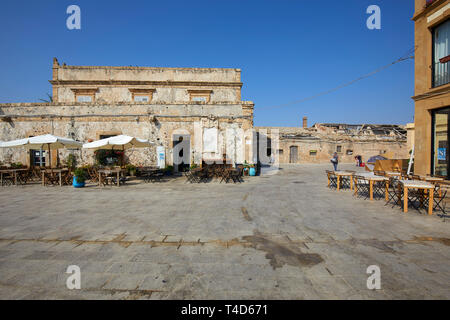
[0,164,450,299]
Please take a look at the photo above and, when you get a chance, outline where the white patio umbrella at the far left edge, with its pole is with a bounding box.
[0,134,82,165]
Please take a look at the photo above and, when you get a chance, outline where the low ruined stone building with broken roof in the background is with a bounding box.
[255,118,409,164]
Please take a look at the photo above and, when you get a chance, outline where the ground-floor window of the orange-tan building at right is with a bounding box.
[431,108,450,177]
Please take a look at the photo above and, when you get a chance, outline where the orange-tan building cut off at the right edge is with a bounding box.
[412,0,450,177]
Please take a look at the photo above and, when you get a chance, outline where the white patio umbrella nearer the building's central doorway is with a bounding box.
[83,134,154,151]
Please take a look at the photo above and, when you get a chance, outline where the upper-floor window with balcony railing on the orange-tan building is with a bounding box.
[433,20,450,87]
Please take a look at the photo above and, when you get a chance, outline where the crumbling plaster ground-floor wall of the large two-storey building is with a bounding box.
[0,104,252,165]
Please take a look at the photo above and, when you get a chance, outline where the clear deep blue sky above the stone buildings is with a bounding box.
[0,0,414,126]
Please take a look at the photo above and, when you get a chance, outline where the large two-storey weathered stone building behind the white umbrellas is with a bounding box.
[0,58,254,170]
